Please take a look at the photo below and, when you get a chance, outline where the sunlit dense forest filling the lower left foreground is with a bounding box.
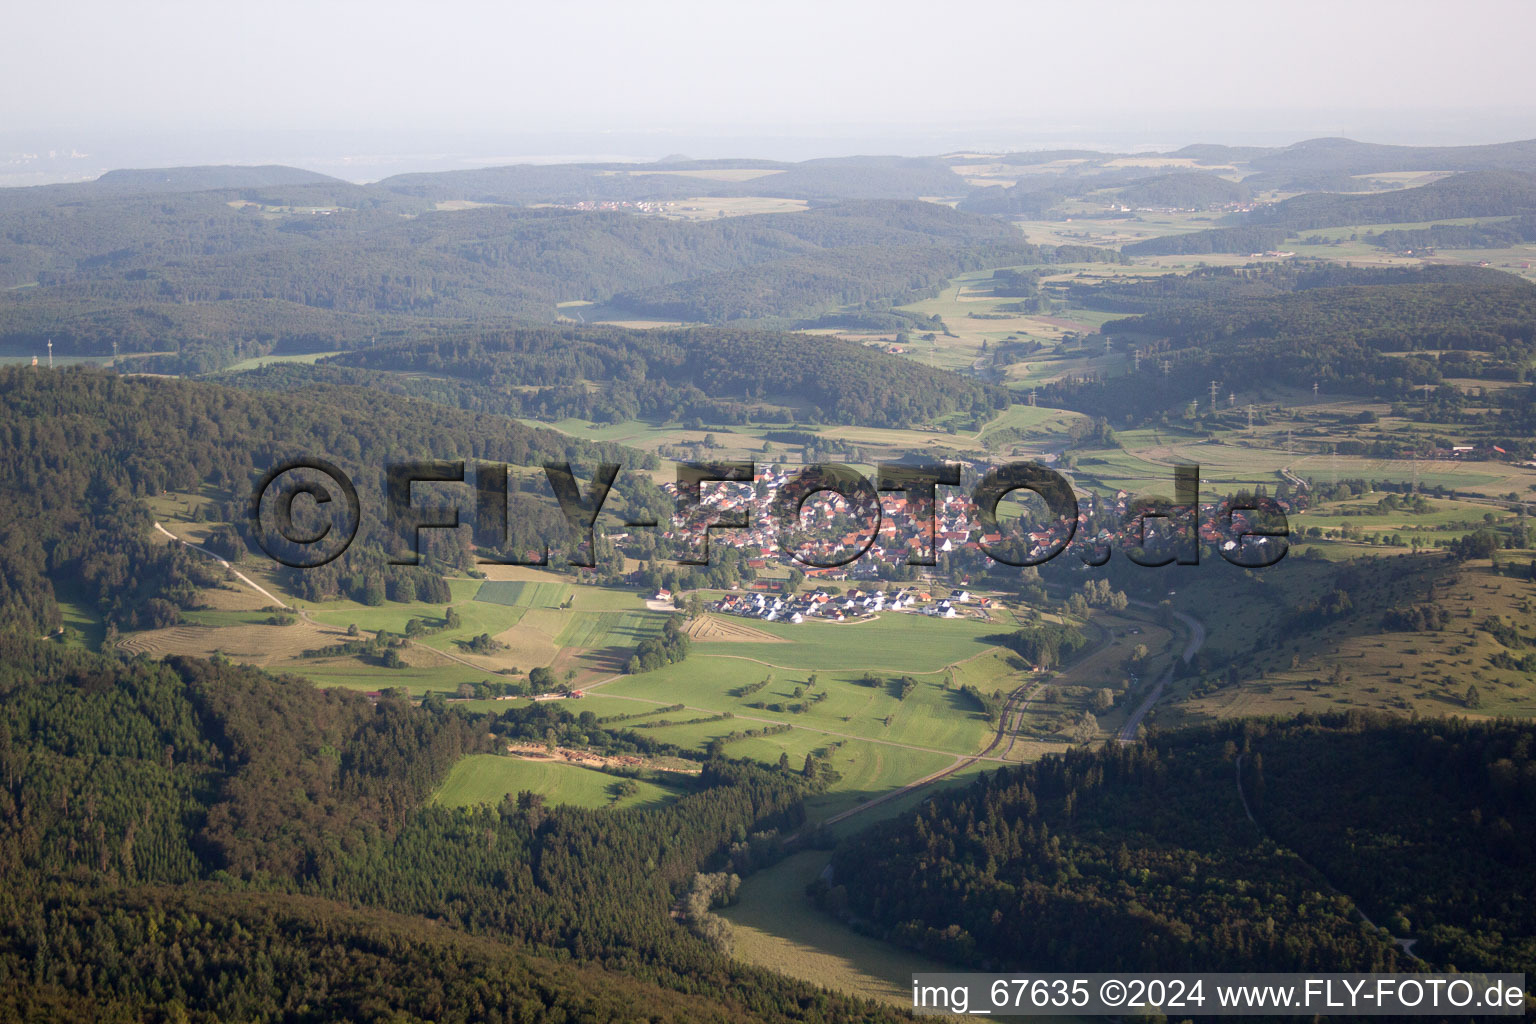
[0,629,895,1024]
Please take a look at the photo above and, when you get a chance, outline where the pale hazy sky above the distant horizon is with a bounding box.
[0,0,1536,178]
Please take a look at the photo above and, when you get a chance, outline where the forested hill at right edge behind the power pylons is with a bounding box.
[1043,267,1536,422]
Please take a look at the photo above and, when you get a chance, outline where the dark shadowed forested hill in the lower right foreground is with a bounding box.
[820,715,1536,972]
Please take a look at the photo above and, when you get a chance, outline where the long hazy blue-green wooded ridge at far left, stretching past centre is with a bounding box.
[0,183,1035,372]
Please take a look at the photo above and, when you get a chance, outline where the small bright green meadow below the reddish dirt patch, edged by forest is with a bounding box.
[433,754,682,809]
